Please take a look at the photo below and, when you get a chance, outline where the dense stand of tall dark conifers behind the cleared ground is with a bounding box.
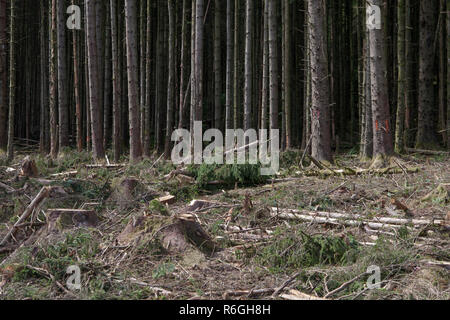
[0,0,450,165]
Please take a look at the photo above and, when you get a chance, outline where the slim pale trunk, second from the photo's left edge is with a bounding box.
[7,0,16,161]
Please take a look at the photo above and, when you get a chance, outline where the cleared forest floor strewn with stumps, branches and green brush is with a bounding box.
[0,151,450,300]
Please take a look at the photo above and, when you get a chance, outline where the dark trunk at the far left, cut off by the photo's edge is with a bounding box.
[0,0,7,151]
